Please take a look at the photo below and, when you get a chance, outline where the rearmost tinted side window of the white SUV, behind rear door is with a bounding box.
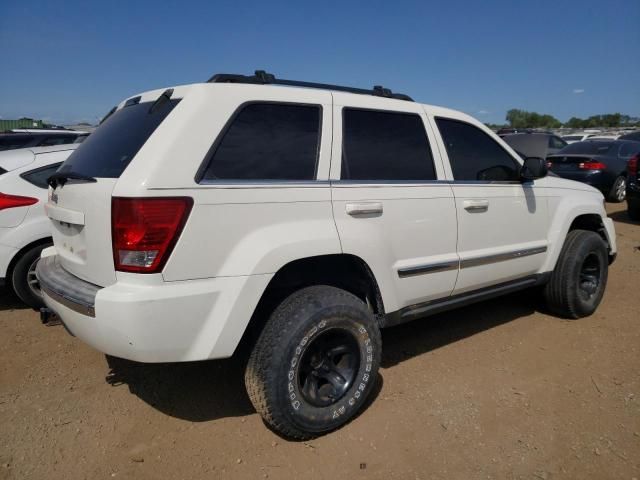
[203,103,321,180]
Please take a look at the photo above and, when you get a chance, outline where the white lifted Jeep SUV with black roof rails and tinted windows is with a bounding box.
[37,72,616,438]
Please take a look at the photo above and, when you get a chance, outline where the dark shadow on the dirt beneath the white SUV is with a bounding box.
[106,291,536,422]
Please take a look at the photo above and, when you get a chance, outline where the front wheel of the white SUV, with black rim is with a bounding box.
[544,230,609,318]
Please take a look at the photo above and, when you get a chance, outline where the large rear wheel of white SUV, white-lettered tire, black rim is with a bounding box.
[245,285,382,439]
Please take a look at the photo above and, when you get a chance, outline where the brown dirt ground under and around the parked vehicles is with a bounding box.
[0,205,640,480]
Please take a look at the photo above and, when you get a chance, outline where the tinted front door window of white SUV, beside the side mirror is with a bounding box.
[436,118,520,181]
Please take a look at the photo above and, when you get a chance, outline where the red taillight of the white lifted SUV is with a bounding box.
[111,197,193,273]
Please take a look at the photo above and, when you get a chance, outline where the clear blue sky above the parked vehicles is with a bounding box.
[0,0,640,123]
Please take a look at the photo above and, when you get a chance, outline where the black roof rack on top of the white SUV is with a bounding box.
[207,70,413,102]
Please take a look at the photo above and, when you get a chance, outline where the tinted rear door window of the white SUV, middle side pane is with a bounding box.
[341,108,436,180]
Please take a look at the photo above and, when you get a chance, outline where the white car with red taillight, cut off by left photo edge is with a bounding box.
[0,144,78,308]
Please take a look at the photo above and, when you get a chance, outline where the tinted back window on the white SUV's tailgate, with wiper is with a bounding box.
[60,100,180,178]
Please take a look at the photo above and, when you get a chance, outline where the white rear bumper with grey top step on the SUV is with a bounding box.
[37,255,272,362]
